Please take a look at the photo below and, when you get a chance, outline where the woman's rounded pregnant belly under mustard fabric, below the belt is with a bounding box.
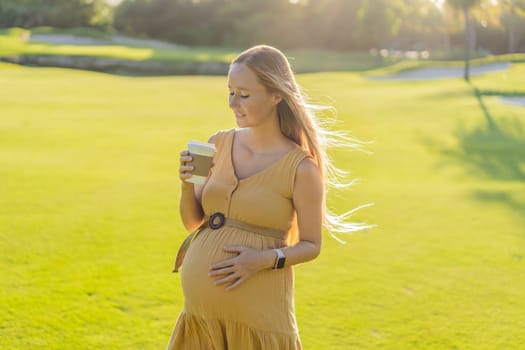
[181,228,286,320]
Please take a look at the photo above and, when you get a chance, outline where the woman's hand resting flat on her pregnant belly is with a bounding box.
[209,246,275,290]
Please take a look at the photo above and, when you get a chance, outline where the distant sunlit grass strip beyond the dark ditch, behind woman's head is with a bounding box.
[0,27,525,75]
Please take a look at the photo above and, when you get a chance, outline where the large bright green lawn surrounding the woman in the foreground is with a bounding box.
[0,60,525,350]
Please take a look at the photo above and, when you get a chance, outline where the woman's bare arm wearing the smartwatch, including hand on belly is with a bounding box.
[209,158,324,290]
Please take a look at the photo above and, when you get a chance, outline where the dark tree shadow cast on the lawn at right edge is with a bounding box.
[444,86,525,220]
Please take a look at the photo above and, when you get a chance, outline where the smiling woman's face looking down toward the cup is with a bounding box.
[228,63,281,128]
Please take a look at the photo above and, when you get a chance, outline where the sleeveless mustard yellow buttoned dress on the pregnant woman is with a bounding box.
[167,129,307,350]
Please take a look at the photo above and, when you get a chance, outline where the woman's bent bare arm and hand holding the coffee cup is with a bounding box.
[179,150,204,232]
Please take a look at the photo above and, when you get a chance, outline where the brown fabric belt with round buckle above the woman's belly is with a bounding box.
[173,212,286,272]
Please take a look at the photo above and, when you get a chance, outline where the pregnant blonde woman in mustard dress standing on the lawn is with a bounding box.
[168,46,362,350]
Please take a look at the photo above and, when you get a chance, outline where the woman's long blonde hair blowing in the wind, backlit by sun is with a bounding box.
[232,45,370,243]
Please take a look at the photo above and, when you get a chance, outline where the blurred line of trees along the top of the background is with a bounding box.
[0,0,525,53]
